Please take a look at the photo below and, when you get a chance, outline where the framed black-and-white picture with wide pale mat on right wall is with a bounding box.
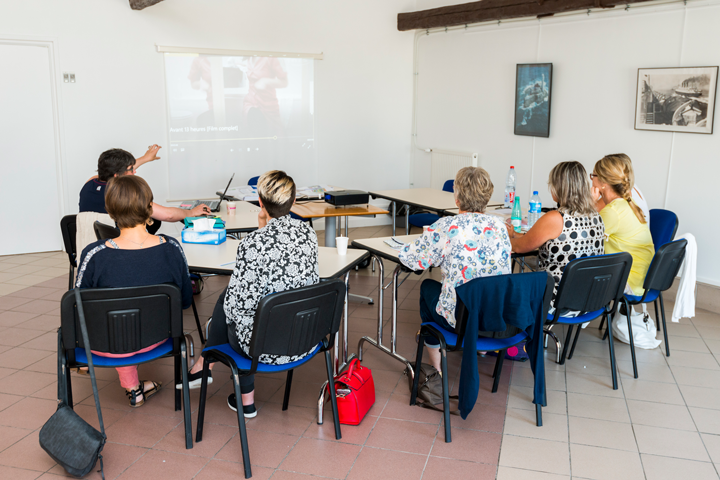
[635,67,718,134]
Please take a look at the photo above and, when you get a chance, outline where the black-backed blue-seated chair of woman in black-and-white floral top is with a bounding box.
[195,280,345,478]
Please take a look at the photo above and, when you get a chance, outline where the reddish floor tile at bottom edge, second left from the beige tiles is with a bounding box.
[347,447,424,480]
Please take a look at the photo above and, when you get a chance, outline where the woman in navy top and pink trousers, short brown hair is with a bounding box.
[75,175,192,407]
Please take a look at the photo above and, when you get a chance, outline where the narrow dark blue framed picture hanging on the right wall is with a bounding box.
[515,63,552,137]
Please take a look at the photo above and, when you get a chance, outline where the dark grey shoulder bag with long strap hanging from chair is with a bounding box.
[40,288,107,480]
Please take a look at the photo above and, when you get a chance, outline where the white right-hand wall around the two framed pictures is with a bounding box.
[413,0,720,285]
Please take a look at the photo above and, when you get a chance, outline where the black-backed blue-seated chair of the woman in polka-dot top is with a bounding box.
[548,252,637,390]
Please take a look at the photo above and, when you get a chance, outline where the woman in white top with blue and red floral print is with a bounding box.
[399,167,511,371]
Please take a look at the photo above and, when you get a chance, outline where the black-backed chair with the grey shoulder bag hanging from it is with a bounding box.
[58,284,192,449]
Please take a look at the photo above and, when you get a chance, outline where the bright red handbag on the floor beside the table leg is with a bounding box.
[335,358,375,425]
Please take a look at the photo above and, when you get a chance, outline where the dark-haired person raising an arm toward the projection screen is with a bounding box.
[80,145,210,228]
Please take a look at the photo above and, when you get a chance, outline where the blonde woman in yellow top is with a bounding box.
[590,154,655,295]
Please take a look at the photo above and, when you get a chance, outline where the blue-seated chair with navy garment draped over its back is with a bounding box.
[410,272,555,443]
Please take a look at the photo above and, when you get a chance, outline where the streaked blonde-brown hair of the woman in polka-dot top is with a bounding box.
[548,162,597,215]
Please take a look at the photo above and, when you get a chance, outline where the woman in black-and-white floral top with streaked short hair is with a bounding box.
[184,170,320,418]
